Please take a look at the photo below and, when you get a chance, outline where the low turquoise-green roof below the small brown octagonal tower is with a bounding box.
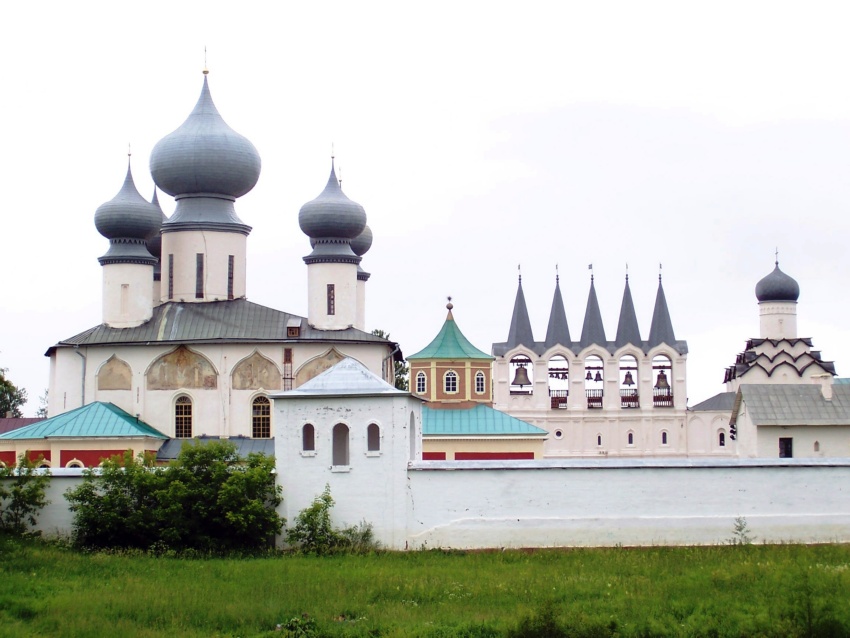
[422,405,546,436]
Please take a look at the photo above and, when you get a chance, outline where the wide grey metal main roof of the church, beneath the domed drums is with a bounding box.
[46,299,402,360]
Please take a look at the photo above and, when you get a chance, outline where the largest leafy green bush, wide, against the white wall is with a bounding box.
[65,441,283,552]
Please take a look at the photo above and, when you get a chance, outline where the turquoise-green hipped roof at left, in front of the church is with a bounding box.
[0,401,168,440]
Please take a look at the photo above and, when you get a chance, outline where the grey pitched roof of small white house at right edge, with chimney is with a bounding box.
[731,383,850,426]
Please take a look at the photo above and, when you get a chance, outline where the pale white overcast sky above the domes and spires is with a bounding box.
[0,1,850,414]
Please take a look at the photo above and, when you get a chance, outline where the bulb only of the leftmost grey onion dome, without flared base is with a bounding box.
[94,163,162,242]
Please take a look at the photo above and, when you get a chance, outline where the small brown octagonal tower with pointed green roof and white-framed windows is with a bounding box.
[407,297,493,407]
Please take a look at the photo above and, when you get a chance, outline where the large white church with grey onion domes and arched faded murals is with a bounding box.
[19,71,401,466]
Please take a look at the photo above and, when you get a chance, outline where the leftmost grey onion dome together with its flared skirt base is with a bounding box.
[94,162,162,265]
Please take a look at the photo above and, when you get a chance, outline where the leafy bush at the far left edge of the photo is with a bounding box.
[0,453,50,534]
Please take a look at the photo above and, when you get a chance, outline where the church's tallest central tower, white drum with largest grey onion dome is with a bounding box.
[150,69,260,302]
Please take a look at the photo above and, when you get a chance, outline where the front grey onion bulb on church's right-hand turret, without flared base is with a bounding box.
[298,163,366,239]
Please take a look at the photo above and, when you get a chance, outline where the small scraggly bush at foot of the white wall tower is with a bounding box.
[286,485,378,556]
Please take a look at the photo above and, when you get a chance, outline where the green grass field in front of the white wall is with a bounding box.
[0,539,850,637]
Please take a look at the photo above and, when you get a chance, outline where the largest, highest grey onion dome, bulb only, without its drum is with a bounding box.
[151,76,260,199]
